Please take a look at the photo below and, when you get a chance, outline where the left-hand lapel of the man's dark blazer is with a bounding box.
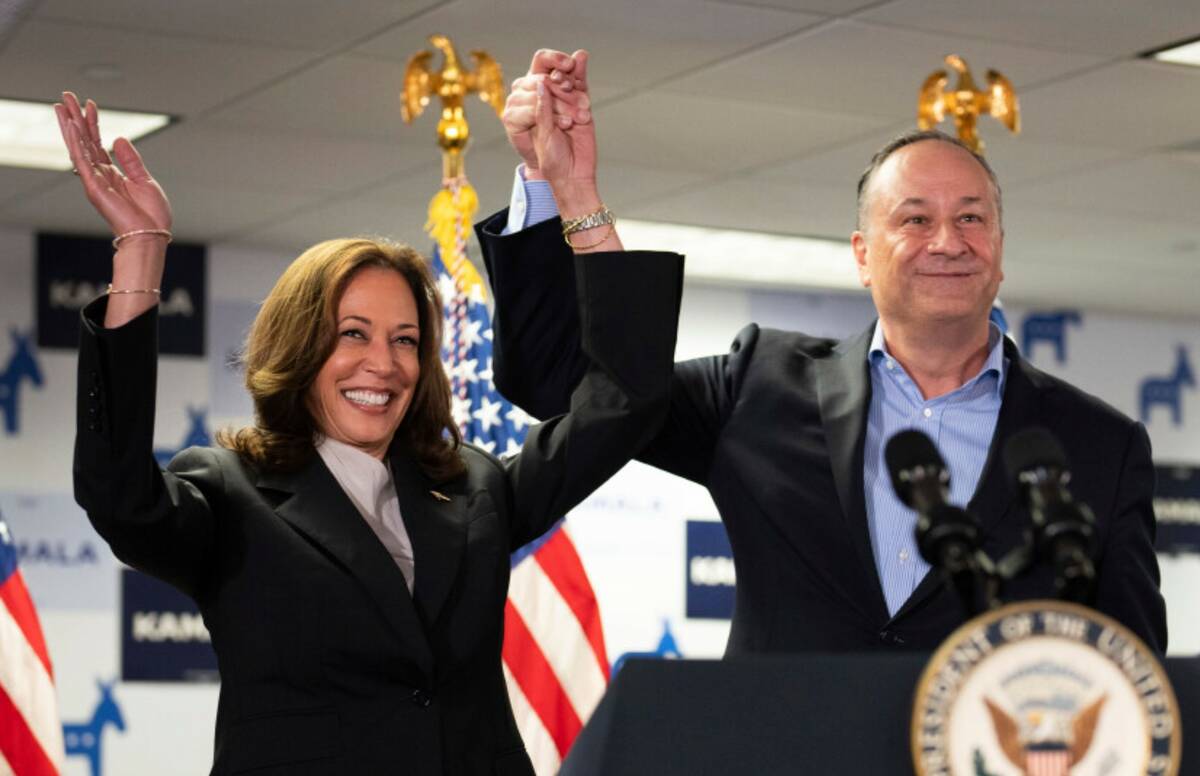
[816,325,888,620]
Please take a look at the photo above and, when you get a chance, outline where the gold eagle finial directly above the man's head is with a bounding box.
[917,54,1021,154]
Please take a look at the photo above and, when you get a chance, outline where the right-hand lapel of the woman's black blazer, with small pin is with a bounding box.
[391,456,467,626]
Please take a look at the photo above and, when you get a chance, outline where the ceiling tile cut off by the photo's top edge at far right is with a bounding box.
[859,0,1200,56]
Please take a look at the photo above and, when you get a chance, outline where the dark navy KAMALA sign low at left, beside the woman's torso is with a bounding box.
[121,569,221,681]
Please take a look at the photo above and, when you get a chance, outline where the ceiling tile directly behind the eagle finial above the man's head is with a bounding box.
[664,22,1099,122]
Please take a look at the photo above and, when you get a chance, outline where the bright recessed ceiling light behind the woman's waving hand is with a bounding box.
[0,98,170,170]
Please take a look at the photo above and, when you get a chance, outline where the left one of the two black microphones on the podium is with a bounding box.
[883,431,979,614]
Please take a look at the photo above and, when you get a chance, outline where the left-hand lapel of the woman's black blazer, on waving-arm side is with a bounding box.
[258,455,433,679]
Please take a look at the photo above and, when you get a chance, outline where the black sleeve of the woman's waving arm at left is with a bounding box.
[73,297,221,596]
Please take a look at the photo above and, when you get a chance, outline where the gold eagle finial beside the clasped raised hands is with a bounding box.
[400,35,504,180]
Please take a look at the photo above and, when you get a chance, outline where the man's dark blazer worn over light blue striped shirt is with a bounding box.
[476,213,1166,655]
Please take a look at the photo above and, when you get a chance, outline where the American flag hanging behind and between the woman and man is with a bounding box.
[432,236,608,776]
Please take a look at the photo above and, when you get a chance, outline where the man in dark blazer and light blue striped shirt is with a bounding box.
[478,50,1166,655]
